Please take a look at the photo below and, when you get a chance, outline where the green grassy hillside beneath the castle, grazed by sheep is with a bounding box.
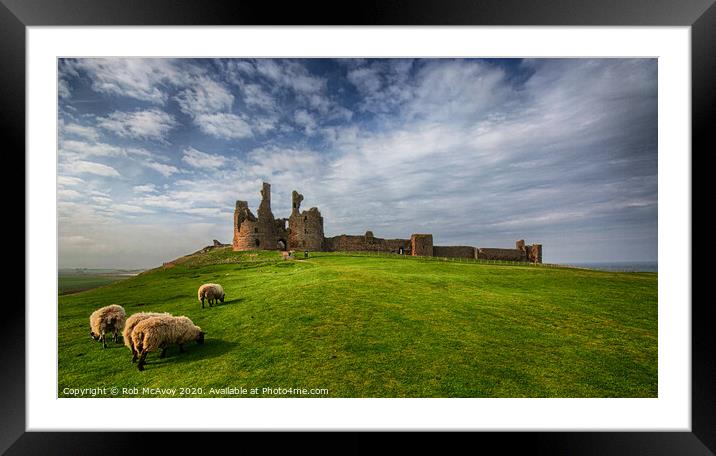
[58,249,658,397]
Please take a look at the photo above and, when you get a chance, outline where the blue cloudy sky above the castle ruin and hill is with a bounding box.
[57,58,657,268]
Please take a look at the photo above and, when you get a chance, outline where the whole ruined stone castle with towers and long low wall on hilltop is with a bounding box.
[232,182,542,263]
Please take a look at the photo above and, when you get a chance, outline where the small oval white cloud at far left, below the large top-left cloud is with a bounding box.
[97,109,178,141]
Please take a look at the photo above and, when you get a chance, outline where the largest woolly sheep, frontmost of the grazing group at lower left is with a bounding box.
[131,315,204,371]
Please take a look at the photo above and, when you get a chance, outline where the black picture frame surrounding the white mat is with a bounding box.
[0,0,716,455]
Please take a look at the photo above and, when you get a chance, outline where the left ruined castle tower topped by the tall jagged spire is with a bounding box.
[232,182,278,251]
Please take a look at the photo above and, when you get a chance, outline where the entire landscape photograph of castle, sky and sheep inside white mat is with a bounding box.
[58,56,661,399]
